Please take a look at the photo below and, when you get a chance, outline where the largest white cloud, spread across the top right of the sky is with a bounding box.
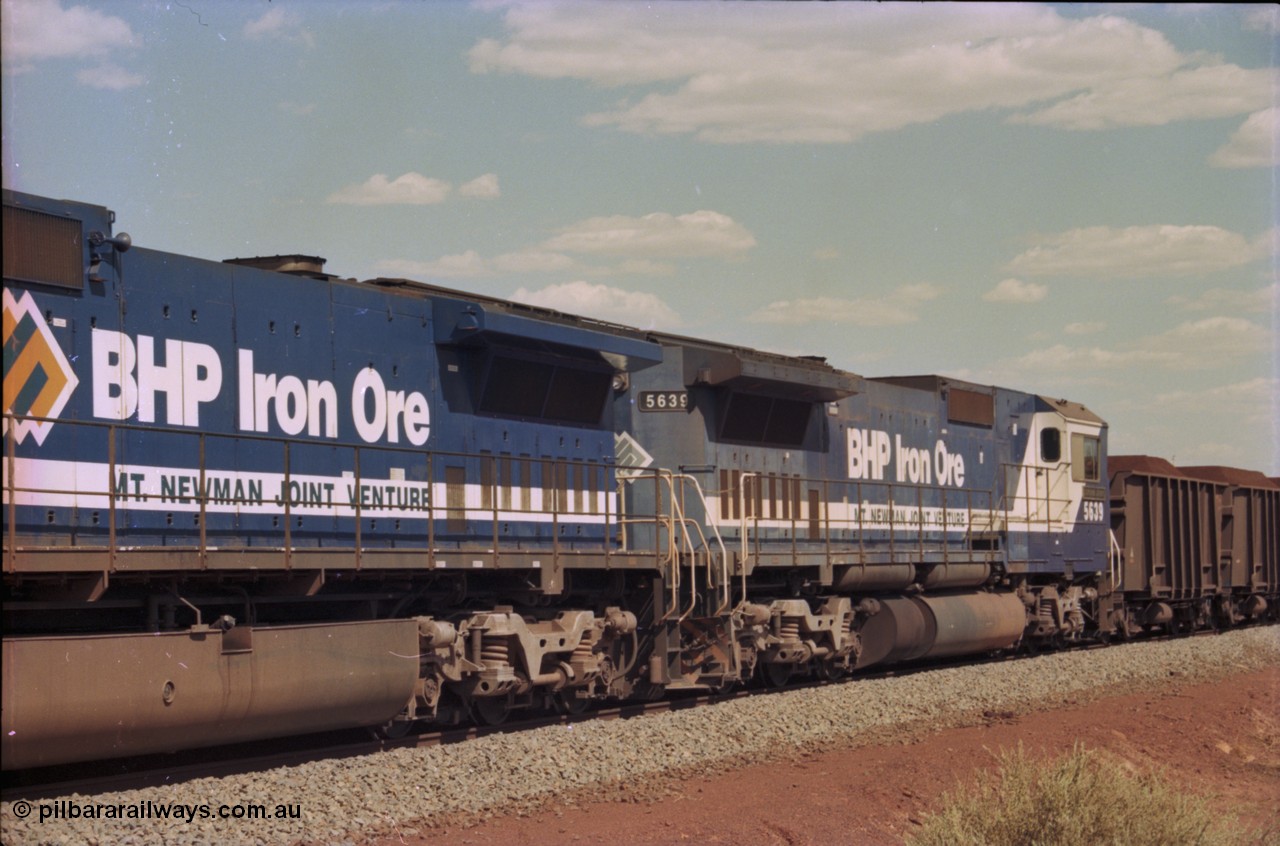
[470,3,1275,143]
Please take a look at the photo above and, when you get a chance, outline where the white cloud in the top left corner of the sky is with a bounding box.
[0,0,134,73]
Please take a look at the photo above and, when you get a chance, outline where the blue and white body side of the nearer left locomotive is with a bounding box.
[5,193,658,555]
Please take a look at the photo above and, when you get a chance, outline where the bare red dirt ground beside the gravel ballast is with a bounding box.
[372,668,1280,846]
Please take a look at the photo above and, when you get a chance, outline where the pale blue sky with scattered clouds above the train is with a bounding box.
[0,0,1280,475]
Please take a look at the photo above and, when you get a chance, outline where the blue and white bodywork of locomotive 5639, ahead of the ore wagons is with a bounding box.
[616,339,1108,575]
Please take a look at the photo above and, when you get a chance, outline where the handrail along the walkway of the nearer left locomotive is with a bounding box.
[3,415,672,572]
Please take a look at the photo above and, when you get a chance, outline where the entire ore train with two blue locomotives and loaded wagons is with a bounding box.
[0,191,1280,769]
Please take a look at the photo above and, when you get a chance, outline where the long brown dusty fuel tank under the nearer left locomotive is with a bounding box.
[0,619,419,769]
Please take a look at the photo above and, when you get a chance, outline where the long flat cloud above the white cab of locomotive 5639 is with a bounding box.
[1005,225,1265,279]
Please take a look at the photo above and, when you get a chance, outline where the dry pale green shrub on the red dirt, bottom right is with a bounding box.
[908,745,1253,846]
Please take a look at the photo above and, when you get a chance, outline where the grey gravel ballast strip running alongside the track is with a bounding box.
[0,626,1280,846]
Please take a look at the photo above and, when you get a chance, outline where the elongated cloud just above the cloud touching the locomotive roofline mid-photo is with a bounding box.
[544,211,755,259]
